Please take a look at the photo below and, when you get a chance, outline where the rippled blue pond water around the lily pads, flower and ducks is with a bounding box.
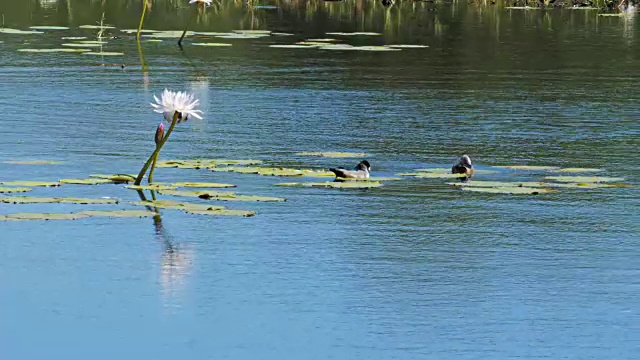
[0,0,640,360]
